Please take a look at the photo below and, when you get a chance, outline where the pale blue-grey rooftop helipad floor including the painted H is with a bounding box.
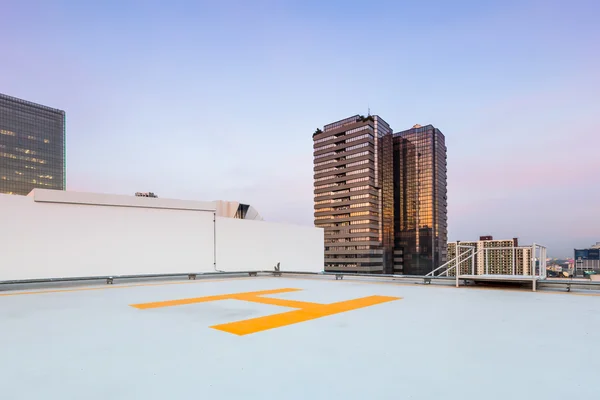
[0,276,600,400]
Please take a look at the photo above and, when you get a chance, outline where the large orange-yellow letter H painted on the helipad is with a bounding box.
[131,288,401,336]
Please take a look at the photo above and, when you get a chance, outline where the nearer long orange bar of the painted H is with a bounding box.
[211,296,400,336]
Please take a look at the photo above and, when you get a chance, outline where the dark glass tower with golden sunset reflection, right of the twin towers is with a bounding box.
[393,125,448,275]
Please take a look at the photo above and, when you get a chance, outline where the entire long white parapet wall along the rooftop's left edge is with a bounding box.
[0,189,324,282]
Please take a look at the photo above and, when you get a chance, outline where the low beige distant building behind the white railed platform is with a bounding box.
[448,236,532,275]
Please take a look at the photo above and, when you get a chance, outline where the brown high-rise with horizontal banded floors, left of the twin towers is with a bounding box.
[313,115,394,273]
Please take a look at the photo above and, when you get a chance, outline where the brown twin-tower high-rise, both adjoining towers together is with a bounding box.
[313,115,447,275]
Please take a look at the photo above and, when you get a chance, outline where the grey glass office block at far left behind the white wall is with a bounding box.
[0,94,66,195]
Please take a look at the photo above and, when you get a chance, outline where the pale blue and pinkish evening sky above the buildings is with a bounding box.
[0,0,600,256]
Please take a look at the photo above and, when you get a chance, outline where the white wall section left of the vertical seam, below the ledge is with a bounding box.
[0,195,214,281]
